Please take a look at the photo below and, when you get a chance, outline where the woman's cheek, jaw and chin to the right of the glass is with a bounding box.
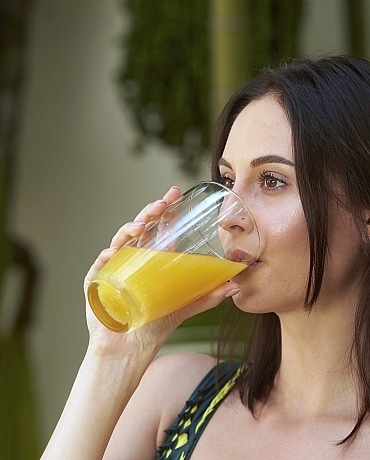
[233,202,310,312]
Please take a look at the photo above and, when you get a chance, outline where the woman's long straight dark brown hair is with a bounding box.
[212,56,370,444]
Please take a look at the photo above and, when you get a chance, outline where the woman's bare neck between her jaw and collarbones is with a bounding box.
[273,306,357,417]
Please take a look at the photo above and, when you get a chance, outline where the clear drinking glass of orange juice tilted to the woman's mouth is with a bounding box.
[88,182,260,332]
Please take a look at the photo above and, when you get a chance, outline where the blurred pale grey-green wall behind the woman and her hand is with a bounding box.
[13,0,370,450]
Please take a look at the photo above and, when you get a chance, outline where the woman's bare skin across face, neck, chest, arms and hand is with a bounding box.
[42,97,370,460]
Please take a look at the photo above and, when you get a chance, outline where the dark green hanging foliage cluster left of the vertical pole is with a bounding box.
[119,0,210,173]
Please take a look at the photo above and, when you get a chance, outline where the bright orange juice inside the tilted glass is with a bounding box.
[88,246,246,332]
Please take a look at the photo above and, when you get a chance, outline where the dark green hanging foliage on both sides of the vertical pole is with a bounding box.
[119,0,302,174]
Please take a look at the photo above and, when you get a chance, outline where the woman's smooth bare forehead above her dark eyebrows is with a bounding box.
[223,96,293,159]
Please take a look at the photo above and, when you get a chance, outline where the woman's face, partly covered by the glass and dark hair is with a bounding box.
[219,96,360,312]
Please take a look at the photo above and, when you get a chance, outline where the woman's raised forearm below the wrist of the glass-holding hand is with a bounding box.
[41,351,150,460]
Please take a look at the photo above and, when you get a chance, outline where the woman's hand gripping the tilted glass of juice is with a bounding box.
[84,187,238,354]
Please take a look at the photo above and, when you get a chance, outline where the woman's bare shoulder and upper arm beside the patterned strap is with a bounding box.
[104,353,216,460]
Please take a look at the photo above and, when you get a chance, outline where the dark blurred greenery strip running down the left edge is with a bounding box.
[0,0,38,460]
